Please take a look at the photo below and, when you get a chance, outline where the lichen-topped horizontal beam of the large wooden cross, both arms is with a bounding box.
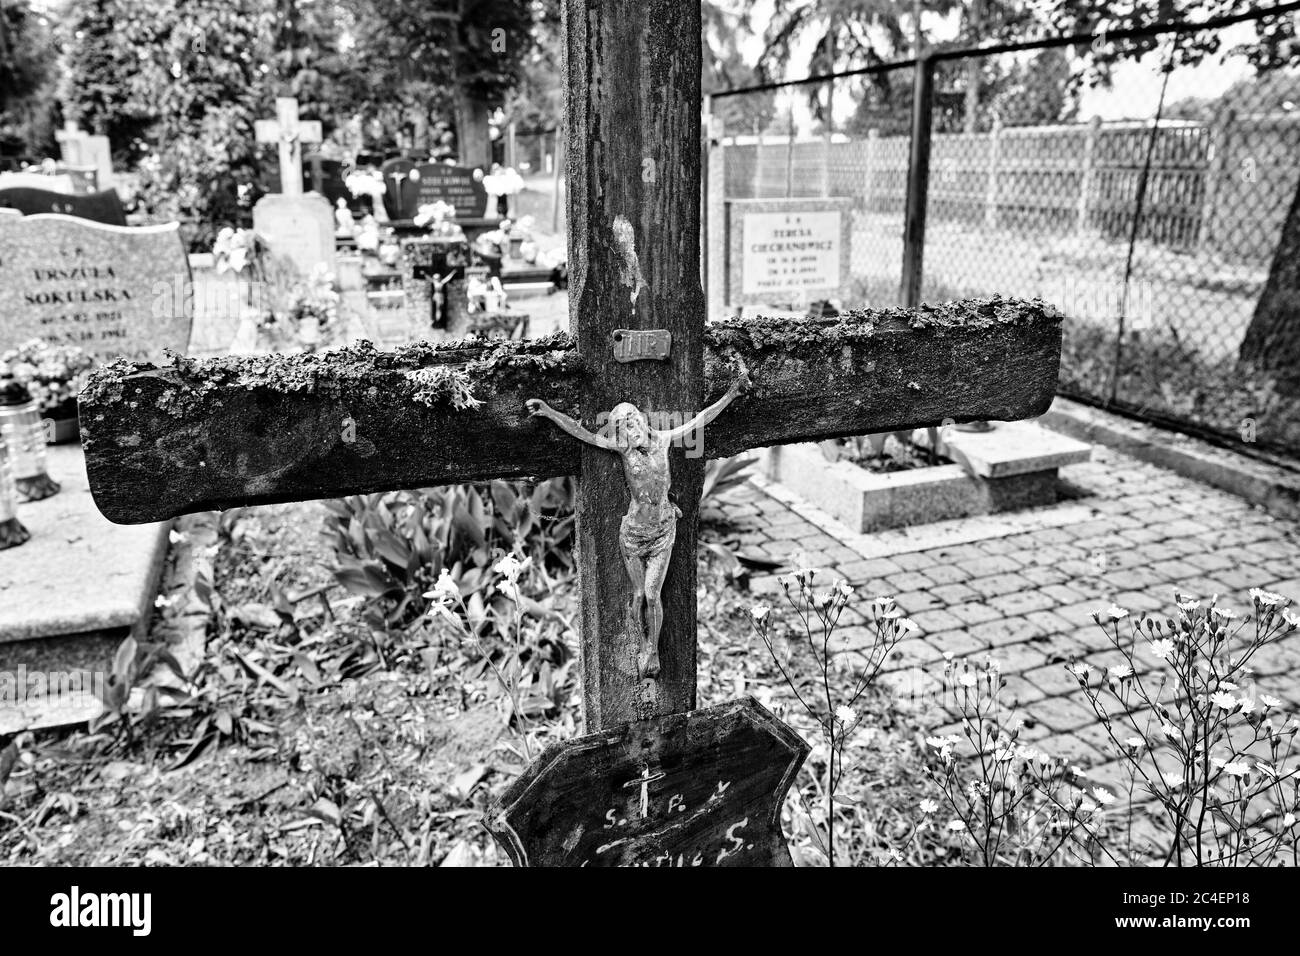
[79,299,1061,524]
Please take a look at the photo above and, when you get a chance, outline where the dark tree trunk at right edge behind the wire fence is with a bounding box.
[1239,174,1300,397]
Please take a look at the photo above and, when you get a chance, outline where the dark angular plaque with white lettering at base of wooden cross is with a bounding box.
[485,697,809,866]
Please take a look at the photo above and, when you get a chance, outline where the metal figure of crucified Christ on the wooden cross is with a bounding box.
[524,363,750,678]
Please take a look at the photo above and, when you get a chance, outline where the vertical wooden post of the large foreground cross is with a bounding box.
[564,0,705,731]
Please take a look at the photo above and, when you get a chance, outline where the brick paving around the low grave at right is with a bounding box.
[706,446,1300,766]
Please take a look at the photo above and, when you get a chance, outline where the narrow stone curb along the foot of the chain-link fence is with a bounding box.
[1039,395,1300,519]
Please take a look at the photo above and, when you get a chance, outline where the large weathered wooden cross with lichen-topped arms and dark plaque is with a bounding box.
[81,0,1061,865]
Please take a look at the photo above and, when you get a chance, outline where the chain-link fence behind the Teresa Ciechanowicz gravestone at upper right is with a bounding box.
[715,12,1300,455]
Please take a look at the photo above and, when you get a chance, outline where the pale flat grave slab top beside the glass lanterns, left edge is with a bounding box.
[0,445,170,647]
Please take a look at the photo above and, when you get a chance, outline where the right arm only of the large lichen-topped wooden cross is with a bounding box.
[705,298,1061,458]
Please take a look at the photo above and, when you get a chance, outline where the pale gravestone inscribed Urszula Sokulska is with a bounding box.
[0,216,191,362]
